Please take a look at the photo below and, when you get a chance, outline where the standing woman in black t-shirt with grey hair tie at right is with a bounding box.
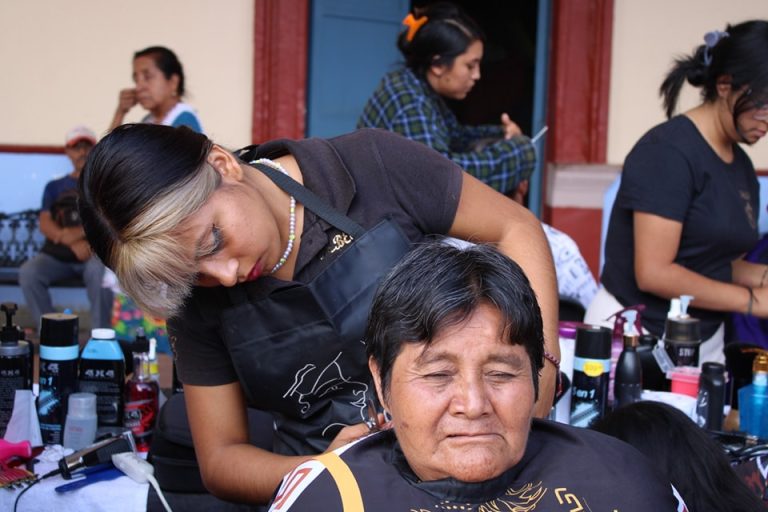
[586,20,768,363]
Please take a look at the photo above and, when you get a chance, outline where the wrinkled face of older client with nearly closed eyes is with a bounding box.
[374,305,534,482]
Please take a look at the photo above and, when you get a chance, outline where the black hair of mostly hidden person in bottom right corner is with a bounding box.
[592,402,765,512]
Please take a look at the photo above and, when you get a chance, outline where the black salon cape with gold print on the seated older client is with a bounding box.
[270,420,684,512]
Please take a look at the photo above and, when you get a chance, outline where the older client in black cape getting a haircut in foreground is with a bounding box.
[271,243,684,512]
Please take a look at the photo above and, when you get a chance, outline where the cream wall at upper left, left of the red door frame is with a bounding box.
[0,0,253,147]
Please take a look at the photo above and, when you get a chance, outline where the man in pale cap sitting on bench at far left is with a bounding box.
[19,126,113,328]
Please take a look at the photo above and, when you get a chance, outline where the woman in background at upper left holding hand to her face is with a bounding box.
[109,46,203,133]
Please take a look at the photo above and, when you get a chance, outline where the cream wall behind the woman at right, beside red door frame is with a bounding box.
[608,0,768,169]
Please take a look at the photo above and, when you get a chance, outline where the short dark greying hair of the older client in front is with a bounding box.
[366,240,544,397]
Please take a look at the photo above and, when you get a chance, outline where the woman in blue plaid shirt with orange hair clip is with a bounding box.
[357,2,536,198]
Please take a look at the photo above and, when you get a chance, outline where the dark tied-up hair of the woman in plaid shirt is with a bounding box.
[397,2,483,76]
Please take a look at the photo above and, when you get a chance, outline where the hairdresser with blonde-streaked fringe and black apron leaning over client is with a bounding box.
[80,124,559,509]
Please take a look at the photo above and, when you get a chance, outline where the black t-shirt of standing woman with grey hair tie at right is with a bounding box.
[601,116,759,339]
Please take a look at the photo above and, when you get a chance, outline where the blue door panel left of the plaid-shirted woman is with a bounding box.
[307,0,410,137]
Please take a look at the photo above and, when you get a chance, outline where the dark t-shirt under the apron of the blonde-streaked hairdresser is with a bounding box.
[168,129,462,385]
